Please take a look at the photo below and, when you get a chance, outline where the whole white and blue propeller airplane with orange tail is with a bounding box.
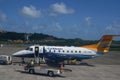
[12,35,120,64]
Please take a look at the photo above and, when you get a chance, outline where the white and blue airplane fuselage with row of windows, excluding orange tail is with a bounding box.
[13,46,98,60]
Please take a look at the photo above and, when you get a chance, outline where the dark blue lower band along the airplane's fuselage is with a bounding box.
[14,52,103,60]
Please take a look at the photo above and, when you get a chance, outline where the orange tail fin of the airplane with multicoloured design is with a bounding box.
[83,35,120,53]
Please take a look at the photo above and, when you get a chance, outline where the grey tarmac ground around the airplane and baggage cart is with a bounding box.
[0,46,120,80]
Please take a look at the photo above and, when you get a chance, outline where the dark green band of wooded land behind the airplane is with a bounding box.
[0,31,120,51]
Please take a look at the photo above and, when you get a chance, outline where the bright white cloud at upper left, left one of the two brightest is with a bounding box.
[21,5,42,18]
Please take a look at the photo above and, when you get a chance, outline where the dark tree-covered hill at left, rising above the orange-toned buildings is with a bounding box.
[0,31,57,41]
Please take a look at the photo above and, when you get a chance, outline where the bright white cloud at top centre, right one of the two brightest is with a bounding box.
[51,3,74,14]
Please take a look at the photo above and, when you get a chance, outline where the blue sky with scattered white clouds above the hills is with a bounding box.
[0,0,120,40]
